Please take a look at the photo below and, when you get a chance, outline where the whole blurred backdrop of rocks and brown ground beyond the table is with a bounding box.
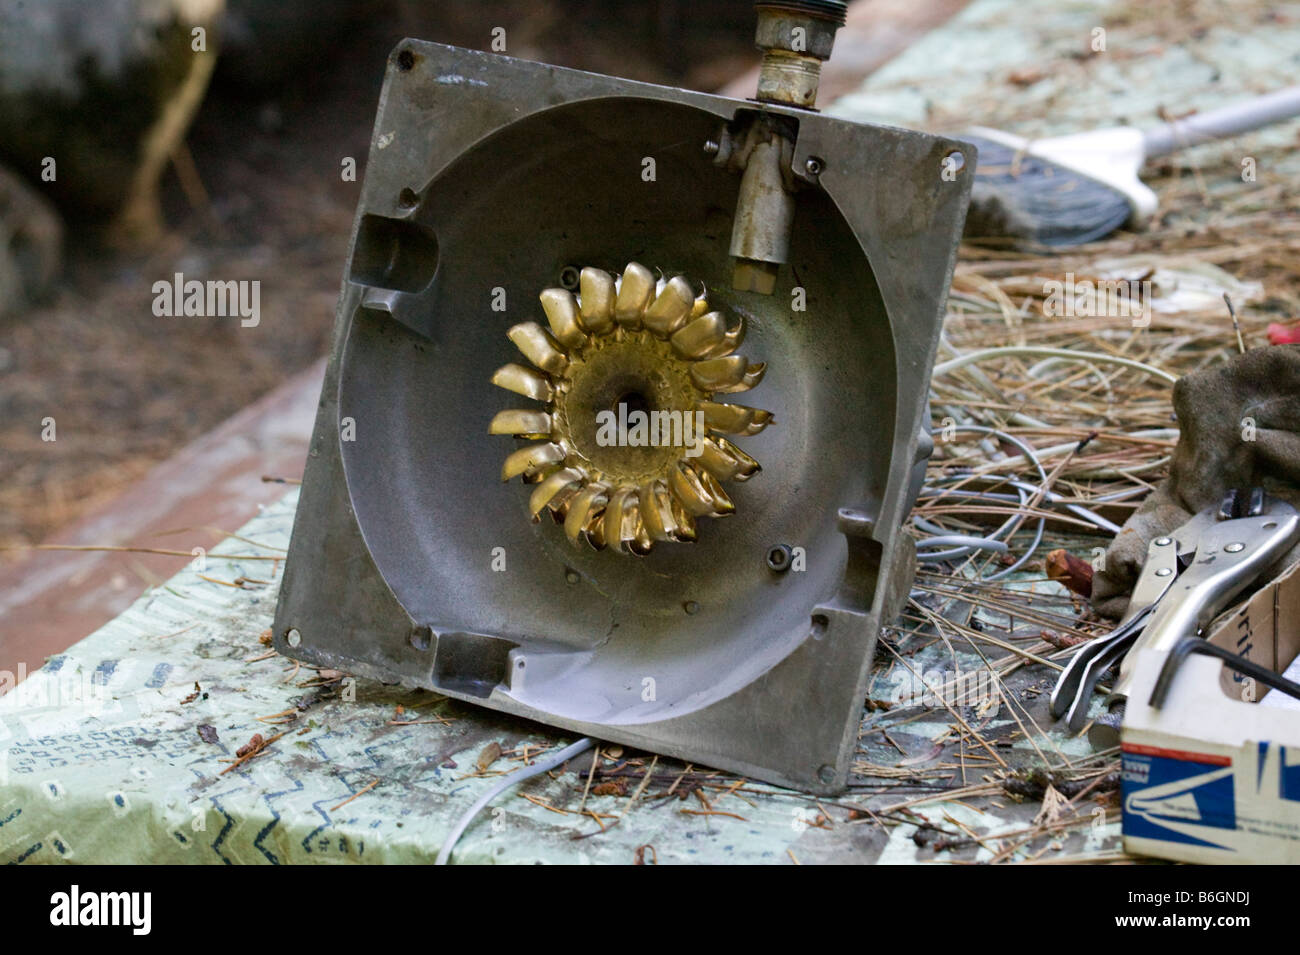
[0,0,758,553]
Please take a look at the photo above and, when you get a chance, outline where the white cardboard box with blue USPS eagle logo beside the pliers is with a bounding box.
[1121,567,1300,864]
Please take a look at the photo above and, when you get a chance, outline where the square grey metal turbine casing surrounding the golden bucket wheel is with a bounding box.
[276,42,974,791]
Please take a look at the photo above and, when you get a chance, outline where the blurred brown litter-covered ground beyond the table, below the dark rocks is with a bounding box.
[0,0,757,561]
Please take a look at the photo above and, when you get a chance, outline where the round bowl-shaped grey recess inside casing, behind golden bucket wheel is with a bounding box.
[339,99,896,724]
